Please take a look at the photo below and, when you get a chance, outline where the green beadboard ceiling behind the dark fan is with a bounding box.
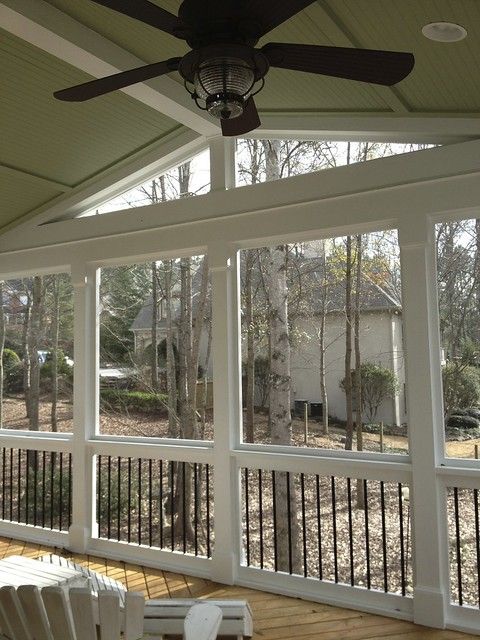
[0,0,480,228]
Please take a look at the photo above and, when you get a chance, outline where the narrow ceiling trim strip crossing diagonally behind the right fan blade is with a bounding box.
[312,0,410,113]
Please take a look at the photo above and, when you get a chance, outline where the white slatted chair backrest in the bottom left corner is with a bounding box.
[0,585,145,640]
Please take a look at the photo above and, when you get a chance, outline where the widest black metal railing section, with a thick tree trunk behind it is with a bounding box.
[242,468,412,596]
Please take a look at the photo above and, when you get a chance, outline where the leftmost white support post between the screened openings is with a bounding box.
[69,264,99,553]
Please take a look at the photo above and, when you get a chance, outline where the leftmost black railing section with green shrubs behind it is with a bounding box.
[0,447,72,531]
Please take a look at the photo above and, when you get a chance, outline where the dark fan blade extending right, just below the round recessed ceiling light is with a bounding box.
[262,42,415,86]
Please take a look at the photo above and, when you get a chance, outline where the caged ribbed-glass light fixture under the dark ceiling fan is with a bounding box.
[192,57,256,120]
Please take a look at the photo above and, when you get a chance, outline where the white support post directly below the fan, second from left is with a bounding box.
[208,246,242,584]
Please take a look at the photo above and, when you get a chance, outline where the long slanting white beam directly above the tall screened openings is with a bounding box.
[5,140,480,254]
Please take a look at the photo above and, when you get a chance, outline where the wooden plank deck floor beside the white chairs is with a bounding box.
[0,538,478,640]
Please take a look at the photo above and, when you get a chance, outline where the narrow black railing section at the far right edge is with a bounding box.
[447,487,480,608]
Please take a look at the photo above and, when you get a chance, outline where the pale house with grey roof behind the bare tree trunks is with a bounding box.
[131,258,406,426]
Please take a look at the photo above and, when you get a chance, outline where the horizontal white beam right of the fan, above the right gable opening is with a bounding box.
[253,113,480,144]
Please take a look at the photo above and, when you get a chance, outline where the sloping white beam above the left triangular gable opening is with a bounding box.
[0,129,207,238]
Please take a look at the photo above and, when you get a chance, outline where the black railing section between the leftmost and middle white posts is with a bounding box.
[97,455,213,558]
